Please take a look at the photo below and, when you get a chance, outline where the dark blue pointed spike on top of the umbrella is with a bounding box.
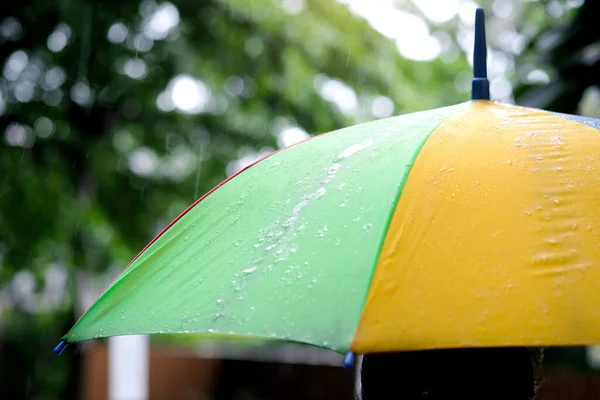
[471,8,490,100]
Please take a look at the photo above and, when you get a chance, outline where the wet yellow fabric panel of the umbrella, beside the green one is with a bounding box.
[351,100,600,353]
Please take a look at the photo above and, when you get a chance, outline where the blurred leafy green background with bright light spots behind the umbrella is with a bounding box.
[0,0,600,400]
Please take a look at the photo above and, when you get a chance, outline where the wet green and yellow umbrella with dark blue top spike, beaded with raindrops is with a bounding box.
[55,10,600,363]
